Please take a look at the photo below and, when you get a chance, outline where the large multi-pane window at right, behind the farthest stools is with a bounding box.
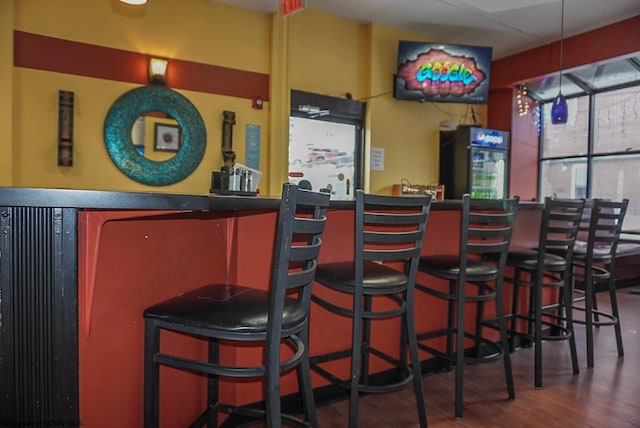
[529,57,640,232]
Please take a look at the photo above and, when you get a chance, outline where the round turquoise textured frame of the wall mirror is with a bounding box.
[104,86,207,186]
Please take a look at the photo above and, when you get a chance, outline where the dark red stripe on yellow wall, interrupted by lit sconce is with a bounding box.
[13,30,269,101]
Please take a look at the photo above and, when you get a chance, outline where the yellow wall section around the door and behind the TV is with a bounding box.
[289,9,486,194]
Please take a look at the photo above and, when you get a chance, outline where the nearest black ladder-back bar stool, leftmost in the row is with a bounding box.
[144,184,329,428]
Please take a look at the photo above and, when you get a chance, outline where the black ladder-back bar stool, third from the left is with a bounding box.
[416,195,518,418]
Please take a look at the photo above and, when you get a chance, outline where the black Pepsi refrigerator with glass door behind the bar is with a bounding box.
[440,125,509,199]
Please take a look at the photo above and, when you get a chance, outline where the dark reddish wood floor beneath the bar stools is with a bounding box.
[317,287,640,428]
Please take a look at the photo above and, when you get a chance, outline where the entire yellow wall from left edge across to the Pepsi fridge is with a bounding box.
[0,0,484,194]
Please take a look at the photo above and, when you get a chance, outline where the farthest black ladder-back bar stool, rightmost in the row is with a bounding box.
[571,199,629,367]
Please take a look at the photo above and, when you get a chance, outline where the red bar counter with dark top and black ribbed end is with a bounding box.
[0,188,540,428]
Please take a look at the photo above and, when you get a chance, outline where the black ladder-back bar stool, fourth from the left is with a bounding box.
[505,198,584,388]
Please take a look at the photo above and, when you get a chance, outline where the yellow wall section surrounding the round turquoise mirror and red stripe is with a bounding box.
[10,0,271,194]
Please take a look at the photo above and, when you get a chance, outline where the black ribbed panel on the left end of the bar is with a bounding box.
[0,207,80,427]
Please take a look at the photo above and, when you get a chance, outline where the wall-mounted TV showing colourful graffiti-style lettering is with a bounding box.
[394,40,491,104]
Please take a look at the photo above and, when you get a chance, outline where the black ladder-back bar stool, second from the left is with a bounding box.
[311,190,431,427]
